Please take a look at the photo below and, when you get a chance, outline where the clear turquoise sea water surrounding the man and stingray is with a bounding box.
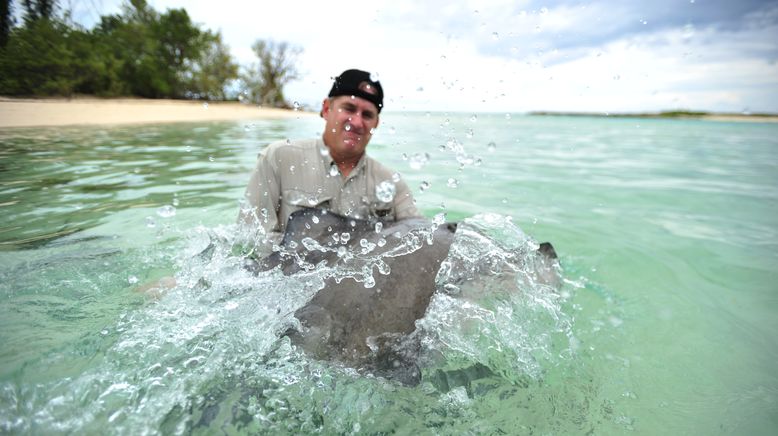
[0,114,778,434]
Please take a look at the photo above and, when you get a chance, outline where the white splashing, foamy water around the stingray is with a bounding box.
[0,215,570,434]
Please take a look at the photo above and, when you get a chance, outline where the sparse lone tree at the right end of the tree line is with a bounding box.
[243,40,302,108]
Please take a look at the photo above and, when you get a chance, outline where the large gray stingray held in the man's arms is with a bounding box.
[253,209,556,385]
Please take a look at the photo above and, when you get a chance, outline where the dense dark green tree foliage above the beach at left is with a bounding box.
[0,0,238,99]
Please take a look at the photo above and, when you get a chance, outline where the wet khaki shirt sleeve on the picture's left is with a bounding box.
[238,146,281,242]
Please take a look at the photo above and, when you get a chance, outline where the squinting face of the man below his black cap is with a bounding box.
[322,95,378,161]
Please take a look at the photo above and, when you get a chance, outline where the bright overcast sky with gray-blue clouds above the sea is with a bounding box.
[61,0,778,113]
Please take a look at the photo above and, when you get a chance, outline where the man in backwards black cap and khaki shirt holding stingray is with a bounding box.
[238,70,419,255]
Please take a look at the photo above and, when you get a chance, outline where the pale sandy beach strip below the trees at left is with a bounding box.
[0,97,316,128]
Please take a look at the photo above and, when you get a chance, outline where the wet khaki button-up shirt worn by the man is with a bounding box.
[238,138,420,242]
